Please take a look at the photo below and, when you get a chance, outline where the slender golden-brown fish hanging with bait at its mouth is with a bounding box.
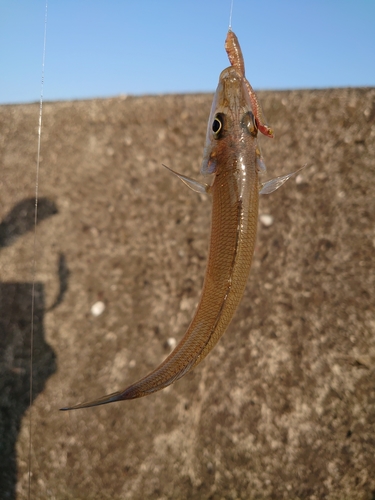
[61,28,303,411]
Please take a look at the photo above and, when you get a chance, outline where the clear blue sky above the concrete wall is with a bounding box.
[0,0,375,103]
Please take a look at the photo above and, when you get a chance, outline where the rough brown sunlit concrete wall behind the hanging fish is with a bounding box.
[0,89,375,500]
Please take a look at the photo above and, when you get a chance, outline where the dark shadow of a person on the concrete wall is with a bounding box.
[0,198,69,500]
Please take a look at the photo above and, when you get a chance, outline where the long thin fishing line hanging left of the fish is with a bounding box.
[27,0,48,500]
